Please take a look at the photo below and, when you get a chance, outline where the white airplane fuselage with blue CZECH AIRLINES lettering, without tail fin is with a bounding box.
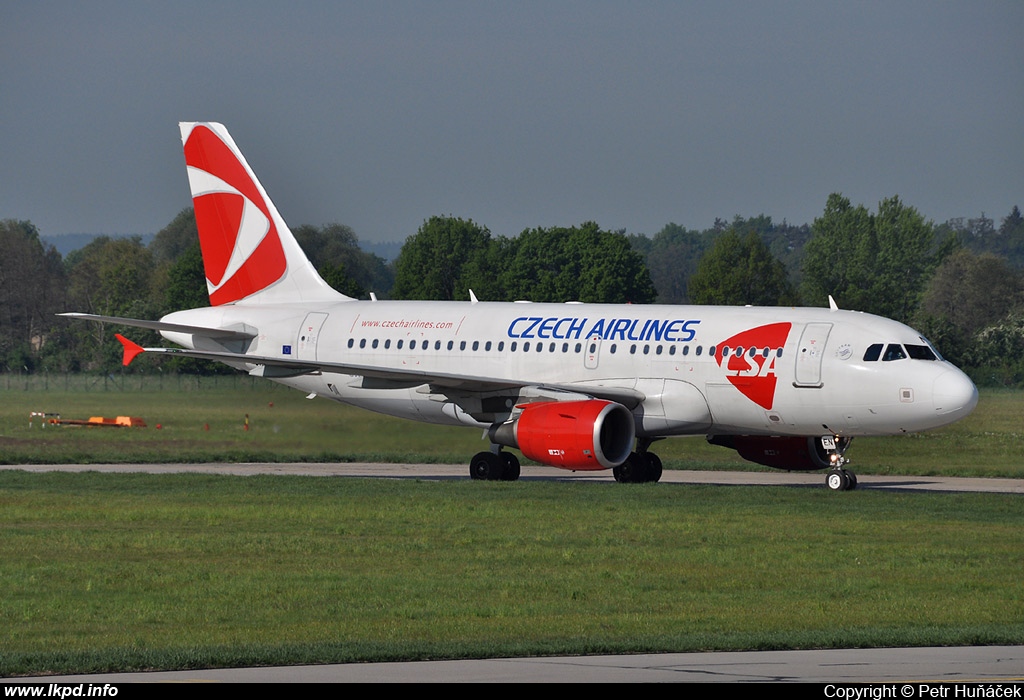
[163,301,978,437]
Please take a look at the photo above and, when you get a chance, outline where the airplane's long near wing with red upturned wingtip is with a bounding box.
[115,335,646,409]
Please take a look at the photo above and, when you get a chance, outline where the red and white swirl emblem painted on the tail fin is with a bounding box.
[184,125,287,306]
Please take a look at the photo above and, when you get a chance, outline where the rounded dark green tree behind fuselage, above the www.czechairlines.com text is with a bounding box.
[391,216,494,301]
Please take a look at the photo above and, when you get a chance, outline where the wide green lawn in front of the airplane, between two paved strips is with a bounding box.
[0,471,1024,675]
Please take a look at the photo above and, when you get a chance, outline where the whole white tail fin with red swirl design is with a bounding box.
[178,122,349,306]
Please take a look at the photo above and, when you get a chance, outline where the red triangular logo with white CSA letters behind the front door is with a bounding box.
[715,323,793,410]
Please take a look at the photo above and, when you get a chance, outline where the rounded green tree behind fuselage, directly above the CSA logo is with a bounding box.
[689,228,797,306]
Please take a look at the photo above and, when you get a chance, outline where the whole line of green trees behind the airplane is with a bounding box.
[0,193,1024,385]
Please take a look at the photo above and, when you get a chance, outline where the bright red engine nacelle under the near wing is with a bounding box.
[490,399,636,470]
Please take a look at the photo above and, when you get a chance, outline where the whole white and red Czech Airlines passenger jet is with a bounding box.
[63,122,978,490]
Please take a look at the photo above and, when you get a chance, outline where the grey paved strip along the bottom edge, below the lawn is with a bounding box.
[12,647,1024,683]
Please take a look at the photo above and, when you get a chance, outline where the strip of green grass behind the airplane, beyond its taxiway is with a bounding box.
[0,375,1024,478]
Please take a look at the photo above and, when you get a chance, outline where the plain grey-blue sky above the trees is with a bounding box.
[0,0,1024,242]
